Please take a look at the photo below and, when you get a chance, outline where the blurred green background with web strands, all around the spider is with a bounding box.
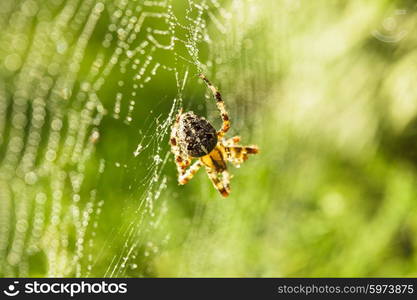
[0,0,417,277]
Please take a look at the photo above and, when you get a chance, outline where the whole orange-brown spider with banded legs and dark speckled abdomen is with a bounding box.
[170,74,259,197]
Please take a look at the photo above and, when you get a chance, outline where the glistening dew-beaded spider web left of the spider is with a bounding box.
[0,0,240,277]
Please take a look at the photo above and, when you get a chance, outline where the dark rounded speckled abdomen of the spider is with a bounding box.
[177,112,217,157]
